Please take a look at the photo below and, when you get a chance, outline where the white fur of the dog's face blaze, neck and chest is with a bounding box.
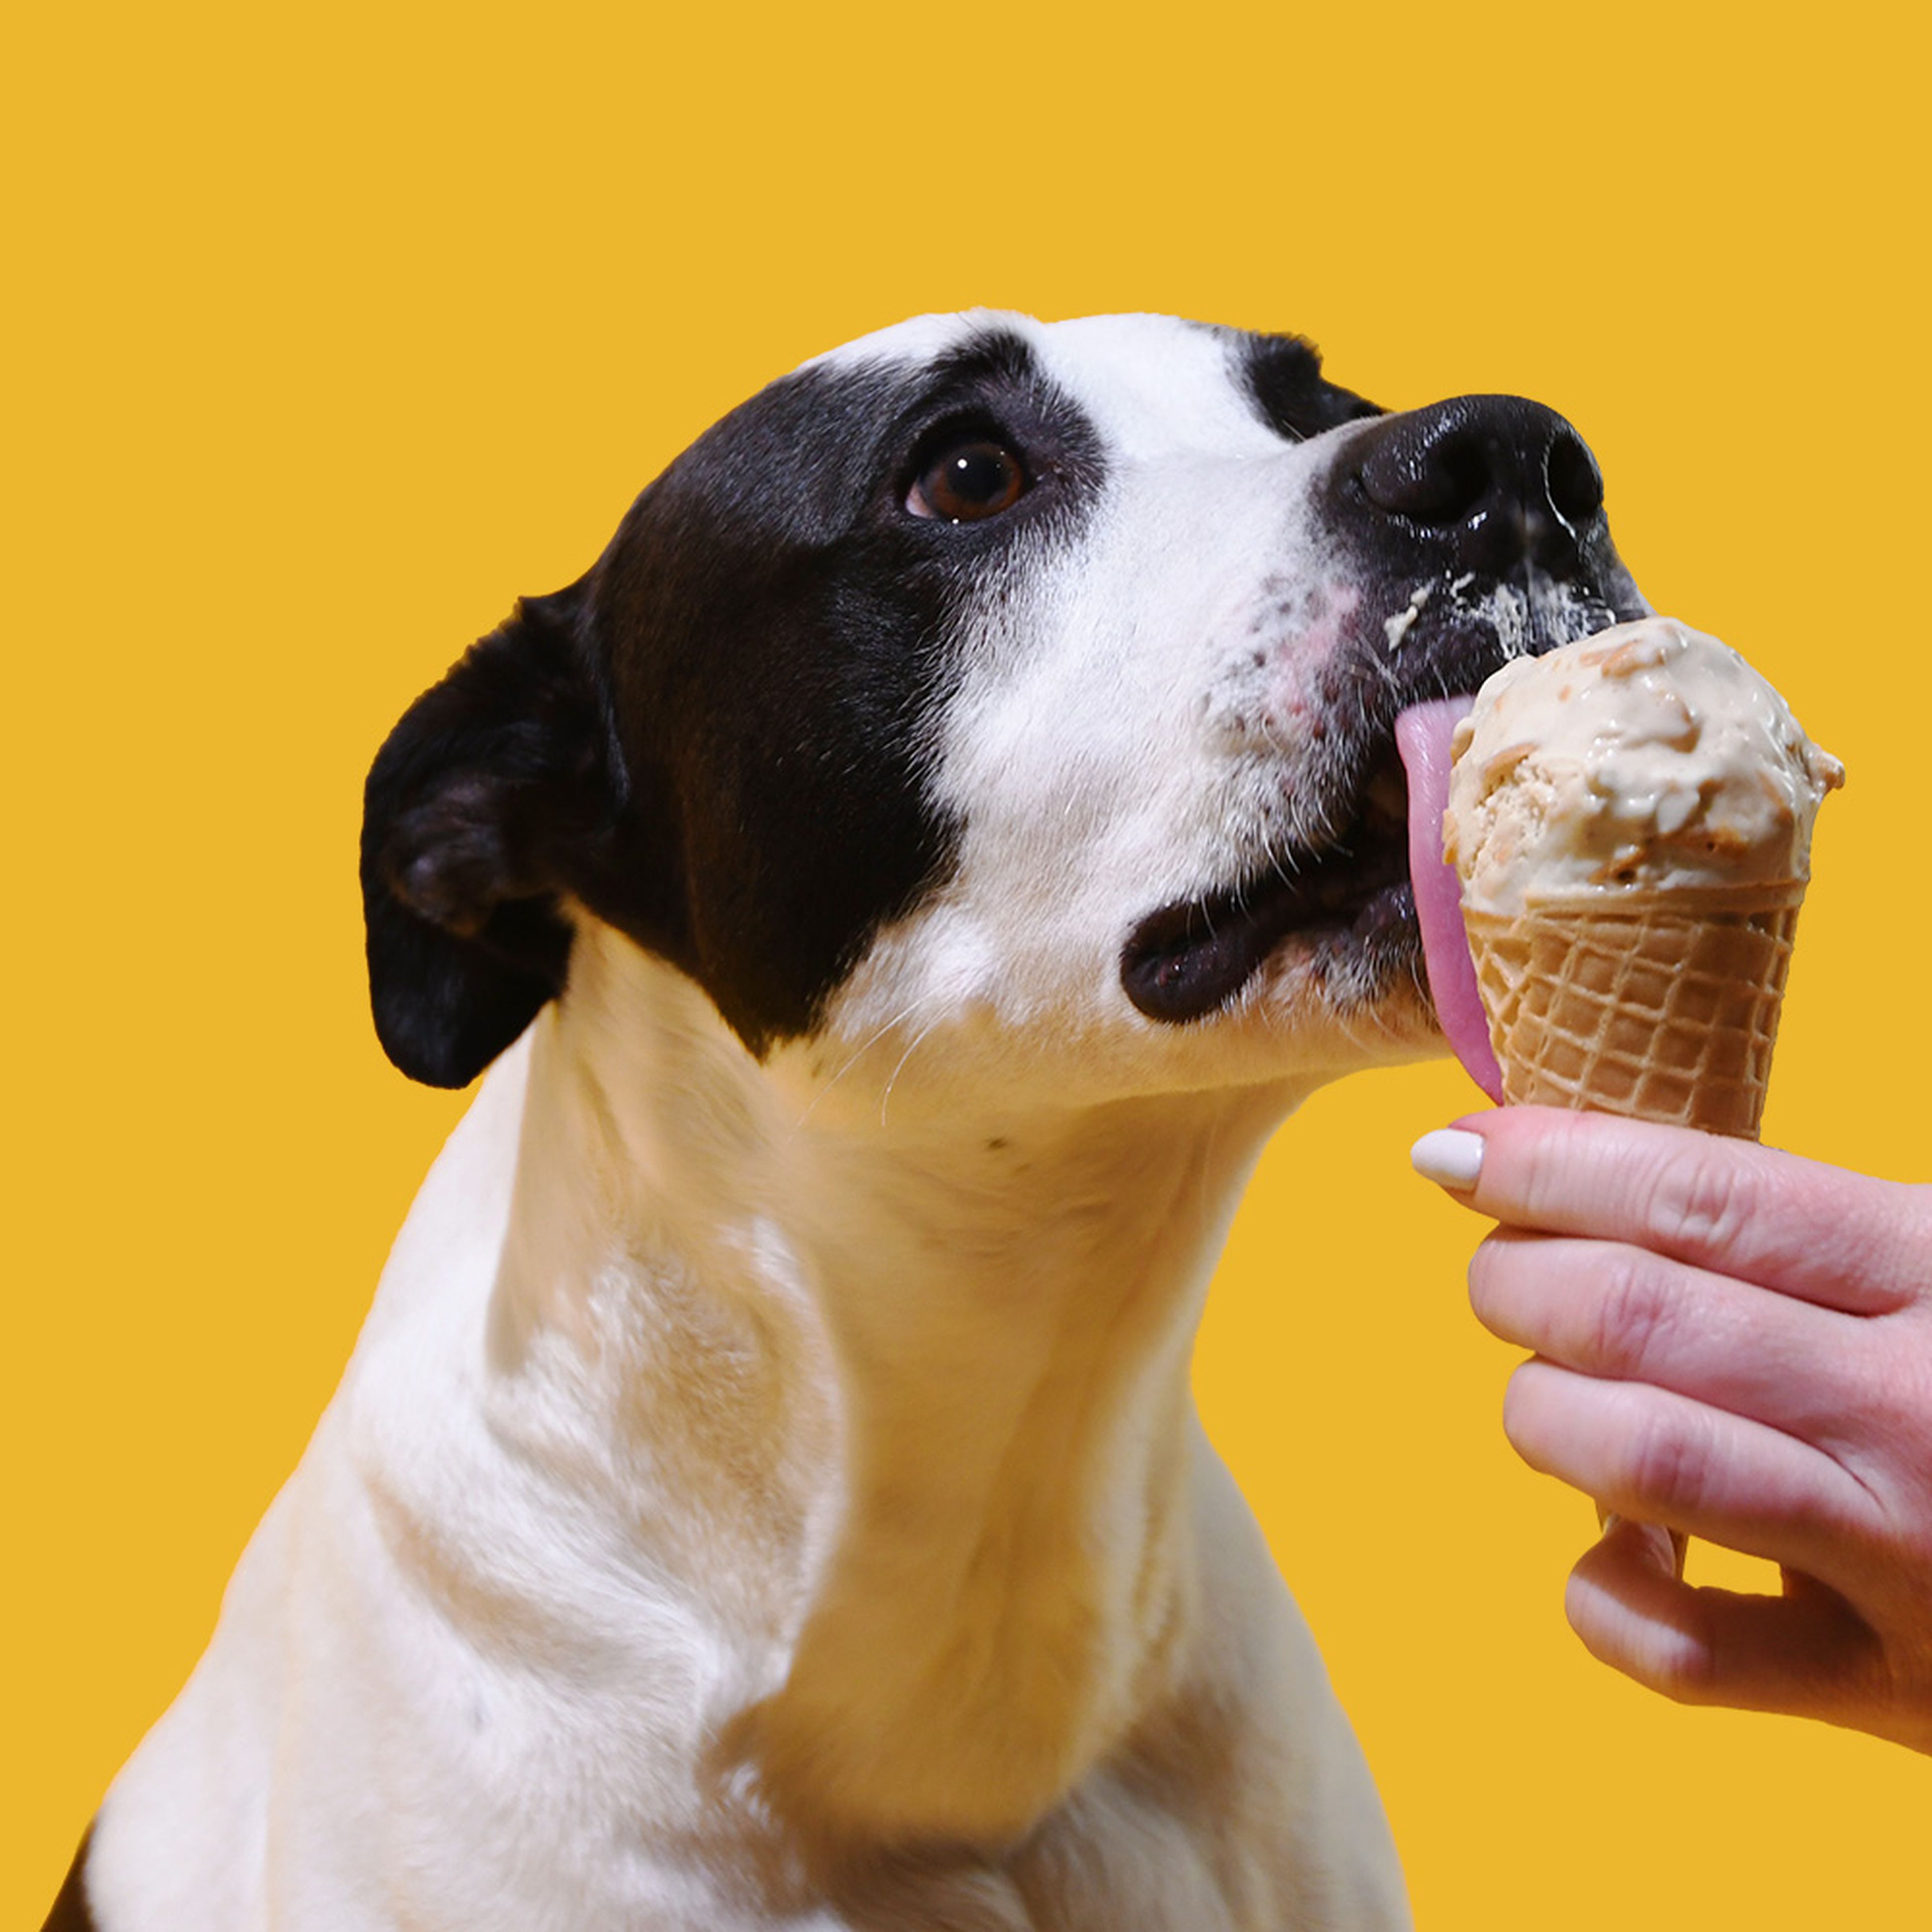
[89,317,1431,1932]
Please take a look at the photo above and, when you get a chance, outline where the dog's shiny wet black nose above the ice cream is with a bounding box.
[1352,396,1603,578]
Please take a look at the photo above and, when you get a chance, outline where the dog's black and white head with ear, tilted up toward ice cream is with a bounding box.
[363,313,1642,1092]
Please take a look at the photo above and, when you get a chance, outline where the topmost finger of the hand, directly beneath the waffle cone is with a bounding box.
[1461,1107,1932,1314]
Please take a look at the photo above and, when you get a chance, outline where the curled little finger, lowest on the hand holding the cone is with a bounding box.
[1563,1522,1882,1720]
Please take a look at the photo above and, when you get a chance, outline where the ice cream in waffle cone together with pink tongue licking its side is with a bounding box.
[1399,618,1845,1575]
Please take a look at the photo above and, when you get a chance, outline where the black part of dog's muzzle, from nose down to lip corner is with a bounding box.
[1120,396,1644,1022]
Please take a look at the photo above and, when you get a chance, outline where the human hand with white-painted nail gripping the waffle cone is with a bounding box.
[1414,1107,1932,1752]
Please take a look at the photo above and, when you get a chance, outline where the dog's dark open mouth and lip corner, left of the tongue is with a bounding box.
[1120,744,1418,1022]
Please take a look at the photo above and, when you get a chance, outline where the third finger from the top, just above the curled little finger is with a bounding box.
[1503,1360,1884,1582]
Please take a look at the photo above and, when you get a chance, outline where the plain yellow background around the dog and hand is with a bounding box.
[0,4,1932,1932]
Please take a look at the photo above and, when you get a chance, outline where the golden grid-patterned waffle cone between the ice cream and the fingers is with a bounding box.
[1463,881,1805,1140]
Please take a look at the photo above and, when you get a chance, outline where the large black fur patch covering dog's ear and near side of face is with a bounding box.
[363,331,1103,1086]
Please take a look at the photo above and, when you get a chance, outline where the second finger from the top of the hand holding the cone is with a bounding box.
[1468,1229,1874,1443]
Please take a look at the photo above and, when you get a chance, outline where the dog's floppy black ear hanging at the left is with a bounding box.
[361,586,622,1088]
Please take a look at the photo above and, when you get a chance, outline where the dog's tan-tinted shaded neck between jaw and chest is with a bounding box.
[491,927,1298,1843]
